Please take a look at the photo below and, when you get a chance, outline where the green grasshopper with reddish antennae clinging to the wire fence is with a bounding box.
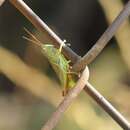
[23,29,77,96]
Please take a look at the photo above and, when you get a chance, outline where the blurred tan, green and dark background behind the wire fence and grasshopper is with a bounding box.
[0,0,130,130]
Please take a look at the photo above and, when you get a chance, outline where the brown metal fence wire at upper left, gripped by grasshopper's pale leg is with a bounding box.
[9,0,80,63]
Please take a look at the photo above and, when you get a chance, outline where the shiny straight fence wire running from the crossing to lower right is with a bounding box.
[84,82,130,130]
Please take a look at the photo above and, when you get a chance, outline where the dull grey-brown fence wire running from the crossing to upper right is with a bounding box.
[73,0,130,71]
